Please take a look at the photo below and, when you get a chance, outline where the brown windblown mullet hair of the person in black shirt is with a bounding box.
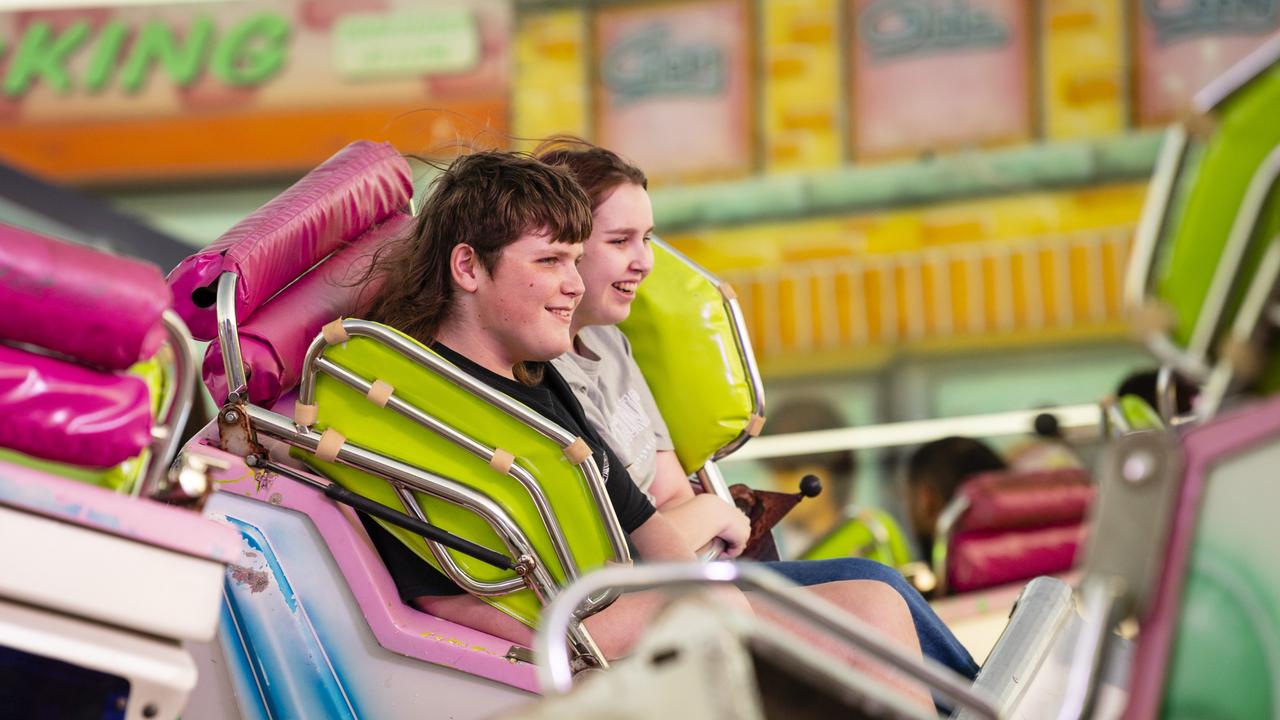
[365,150,591,384]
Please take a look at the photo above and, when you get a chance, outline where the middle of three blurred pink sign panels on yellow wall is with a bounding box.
[849,0,1034,159]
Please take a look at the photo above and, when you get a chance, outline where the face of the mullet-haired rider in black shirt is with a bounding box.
[475,226,582,366]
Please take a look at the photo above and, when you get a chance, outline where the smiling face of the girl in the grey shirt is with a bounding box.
[573,183,653,328]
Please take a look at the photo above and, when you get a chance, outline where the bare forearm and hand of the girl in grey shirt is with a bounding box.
[649,451,751,557]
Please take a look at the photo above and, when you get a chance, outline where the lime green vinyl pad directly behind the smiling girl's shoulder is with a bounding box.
[620,240,764,474]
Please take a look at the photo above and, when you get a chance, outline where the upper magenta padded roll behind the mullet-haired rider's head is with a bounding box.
[169,141,413,340]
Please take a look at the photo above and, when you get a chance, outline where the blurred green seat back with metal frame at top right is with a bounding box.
[1149,51,1280,381]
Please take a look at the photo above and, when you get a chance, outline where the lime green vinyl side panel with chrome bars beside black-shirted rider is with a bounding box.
[302,322,612,626]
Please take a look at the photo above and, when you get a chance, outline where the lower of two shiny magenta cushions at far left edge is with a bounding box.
[0,345,151,468]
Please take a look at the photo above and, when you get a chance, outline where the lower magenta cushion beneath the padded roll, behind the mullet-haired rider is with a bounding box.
[204,213,413,407]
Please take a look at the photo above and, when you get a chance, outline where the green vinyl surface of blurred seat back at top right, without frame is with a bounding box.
[1156,65,1280,346]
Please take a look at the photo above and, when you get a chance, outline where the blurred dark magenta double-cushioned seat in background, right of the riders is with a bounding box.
[946,469,1096,593]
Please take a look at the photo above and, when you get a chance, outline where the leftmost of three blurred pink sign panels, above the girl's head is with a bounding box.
[594,0,754,179]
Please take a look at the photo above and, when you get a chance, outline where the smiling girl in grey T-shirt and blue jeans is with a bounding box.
[538,137,978,679]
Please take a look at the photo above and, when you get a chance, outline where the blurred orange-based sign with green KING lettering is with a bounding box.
[0,0,511,182]
